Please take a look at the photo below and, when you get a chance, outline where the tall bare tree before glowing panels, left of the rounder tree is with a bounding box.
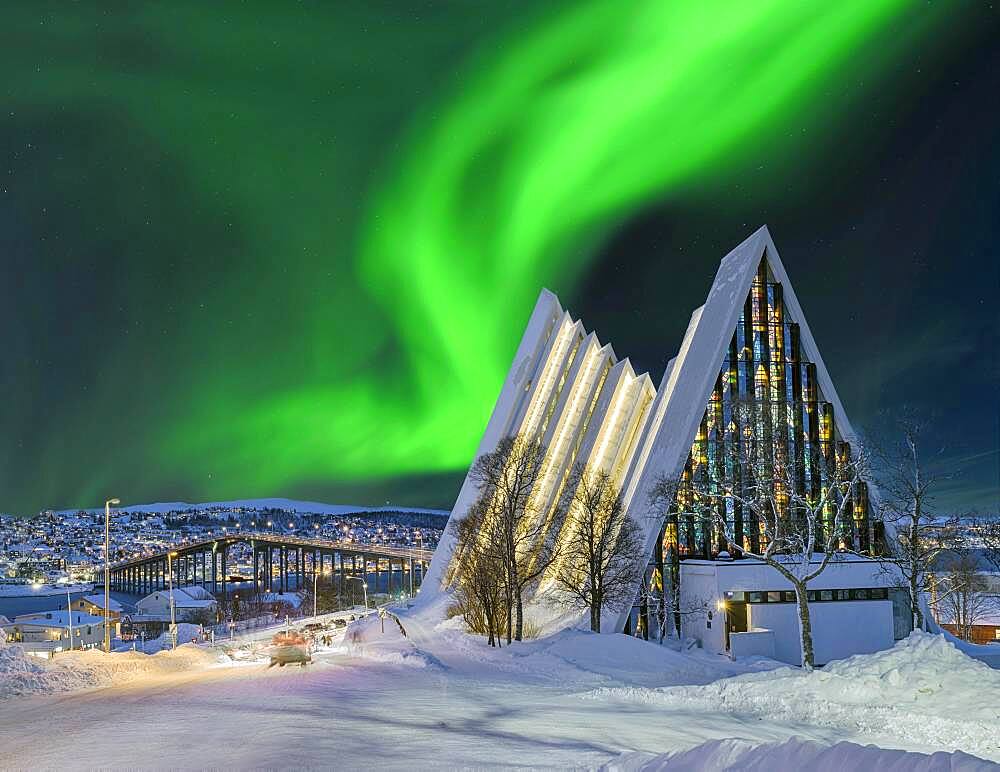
[459,437,559,643]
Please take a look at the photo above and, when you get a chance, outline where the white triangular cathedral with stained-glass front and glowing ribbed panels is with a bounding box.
[424,227,909,664]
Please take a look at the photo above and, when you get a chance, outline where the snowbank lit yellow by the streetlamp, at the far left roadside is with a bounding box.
[0,645,219,700]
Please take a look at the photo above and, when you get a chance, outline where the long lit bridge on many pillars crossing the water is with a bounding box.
[109,533,434,596]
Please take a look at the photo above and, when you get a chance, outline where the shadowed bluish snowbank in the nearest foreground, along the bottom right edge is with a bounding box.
[602,739,997,772]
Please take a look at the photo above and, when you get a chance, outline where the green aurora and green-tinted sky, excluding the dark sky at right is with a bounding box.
[0,0,996,512]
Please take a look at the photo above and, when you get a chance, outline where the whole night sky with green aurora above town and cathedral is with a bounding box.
[0,0,1000,514]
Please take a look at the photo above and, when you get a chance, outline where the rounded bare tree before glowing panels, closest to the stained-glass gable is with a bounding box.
[553,464,645,633]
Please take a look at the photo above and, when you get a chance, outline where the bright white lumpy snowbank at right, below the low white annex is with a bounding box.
[586,631,1000,759]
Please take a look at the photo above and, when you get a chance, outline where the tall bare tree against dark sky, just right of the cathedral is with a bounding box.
[876,416,964,629]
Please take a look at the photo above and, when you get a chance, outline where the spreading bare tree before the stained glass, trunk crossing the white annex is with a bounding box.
[658,408,868,670]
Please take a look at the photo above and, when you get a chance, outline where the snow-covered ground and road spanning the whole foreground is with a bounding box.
[0,614,1000,769]
